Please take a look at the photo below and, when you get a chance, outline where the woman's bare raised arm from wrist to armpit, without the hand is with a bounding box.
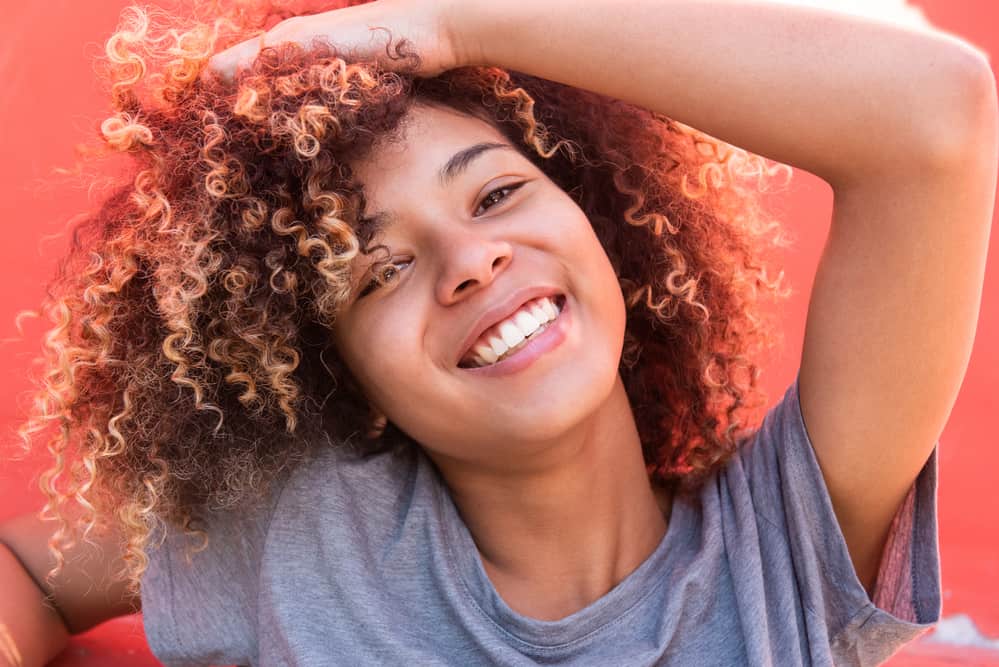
[453,0,999,591]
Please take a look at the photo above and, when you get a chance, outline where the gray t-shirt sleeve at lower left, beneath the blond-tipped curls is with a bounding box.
[141,480,286,667]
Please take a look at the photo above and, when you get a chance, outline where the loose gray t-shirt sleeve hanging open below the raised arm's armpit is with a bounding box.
[738,376,941,665]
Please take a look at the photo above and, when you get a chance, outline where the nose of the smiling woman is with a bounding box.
[437,229,513,305]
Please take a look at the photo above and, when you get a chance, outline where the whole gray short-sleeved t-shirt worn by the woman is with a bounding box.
[142,379,941,667]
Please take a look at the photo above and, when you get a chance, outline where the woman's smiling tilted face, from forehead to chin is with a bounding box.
[333,104,625,467]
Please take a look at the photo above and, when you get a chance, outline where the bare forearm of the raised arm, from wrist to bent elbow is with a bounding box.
[453,0,984,184]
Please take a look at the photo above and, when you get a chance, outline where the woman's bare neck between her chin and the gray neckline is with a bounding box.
[428,378,670,620]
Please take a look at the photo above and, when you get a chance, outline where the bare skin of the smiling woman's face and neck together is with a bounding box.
[333,104,670,620]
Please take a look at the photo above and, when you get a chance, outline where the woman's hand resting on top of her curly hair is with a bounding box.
[208,0,463,79]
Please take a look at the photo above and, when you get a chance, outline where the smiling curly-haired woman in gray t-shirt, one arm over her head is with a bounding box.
[1,0,996,665]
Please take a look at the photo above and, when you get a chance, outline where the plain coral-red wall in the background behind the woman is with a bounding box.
[0,0,999,666]
